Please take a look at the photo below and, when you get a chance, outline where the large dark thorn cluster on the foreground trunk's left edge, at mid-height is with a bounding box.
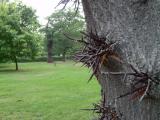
[75,31,119,81]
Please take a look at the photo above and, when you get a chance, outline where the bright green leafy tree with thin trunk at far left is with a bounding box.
[0,3,41,70]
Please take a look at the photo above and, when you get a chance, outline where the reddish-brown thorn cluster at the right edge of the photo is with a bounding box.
[118,65,160,101]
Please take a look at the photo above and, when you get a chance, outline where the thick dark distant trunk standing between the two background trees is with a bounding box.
[47,38,53,63]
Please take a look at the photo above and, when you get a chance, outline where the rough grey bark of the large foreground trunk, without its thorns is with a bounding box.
[82,0,160,120]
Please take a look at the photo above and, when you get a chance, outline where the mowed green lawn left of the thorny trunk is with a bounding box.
[0,62,100,120]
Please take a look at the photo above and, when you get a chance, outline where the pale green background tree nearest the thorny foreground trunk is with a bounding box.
[42,9,84,61]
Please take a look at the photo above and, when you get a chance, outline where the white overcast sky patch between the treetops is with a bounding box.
[21,0,60,25]
